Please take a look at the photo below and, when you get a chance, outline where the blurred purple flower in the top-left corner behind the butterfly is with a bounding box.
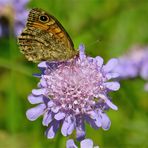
[0,0,28,37]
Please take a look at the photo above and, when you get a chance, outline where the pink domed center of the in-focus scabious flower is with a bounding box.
[44,62,102,114]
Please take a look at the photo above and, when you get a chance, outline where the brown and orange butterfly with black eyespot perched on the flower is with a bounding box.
[18,8,78,62]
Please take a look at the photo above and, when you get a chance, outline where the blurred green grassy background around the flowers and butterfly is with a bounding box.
[0,0,148,148]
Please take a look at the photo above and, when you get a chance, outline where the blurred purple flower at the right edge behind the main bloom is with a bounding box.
[113,46,148,89]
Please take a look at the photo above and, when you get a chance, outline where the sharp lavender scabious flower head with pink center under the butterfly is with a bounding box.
[26,45,120,147]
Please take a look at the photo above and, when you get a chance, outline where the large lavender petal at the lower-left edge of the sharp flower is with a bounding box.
[26,104,46,121]
